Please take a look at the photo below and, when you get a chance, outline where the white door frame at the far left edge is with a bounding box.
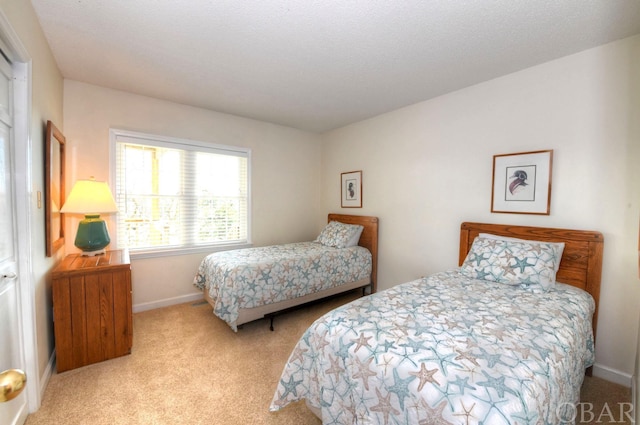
[0,10,41,412]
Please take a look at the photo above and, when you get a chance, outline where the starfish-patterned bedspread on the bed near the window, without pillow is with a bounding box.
[193,242,372,331]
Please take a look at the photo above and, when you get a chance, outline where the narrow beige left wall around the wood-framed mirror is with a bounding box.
[0,0,64,392]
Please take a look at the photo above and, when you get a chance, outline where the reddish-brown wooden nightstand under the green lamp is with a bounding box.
[52,250,133,372]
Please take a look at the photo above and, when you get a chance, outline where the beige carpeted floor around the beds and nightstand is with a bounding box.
[26,293,632,425]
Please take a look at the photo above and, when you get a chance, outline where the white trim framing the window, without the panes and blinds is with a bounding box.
[109,128,253,258]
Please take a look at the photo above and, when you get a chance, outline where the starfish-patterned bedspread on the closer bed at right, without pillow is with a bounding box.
[270,269,595,424]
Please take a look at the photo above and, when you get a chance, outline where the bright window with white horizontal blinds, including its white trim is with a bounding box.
[110,130,251,254]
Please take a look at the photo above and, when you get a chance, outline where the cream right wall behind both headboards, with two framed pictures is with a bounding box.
[318,36,640,386]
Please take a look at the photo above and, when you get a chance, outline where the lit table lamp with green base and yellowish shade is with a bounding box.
[60,178,118,256]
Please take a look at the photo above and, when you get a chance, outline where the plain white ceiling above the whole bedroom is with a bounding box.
[31,0,640,132]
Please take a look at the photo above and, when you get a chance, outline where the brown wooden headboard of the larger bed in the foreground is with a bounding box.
[458,223,604,338]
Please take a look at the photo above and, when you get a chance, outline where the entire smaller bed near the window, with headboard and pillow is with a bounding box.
[194,214,378,330]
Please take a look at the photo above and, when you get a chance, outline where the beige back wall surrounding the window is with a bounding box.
[64,80,326,311]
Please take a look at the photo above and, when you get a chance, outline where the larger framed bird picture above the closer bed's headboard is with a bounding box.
[491,150,553,215]
